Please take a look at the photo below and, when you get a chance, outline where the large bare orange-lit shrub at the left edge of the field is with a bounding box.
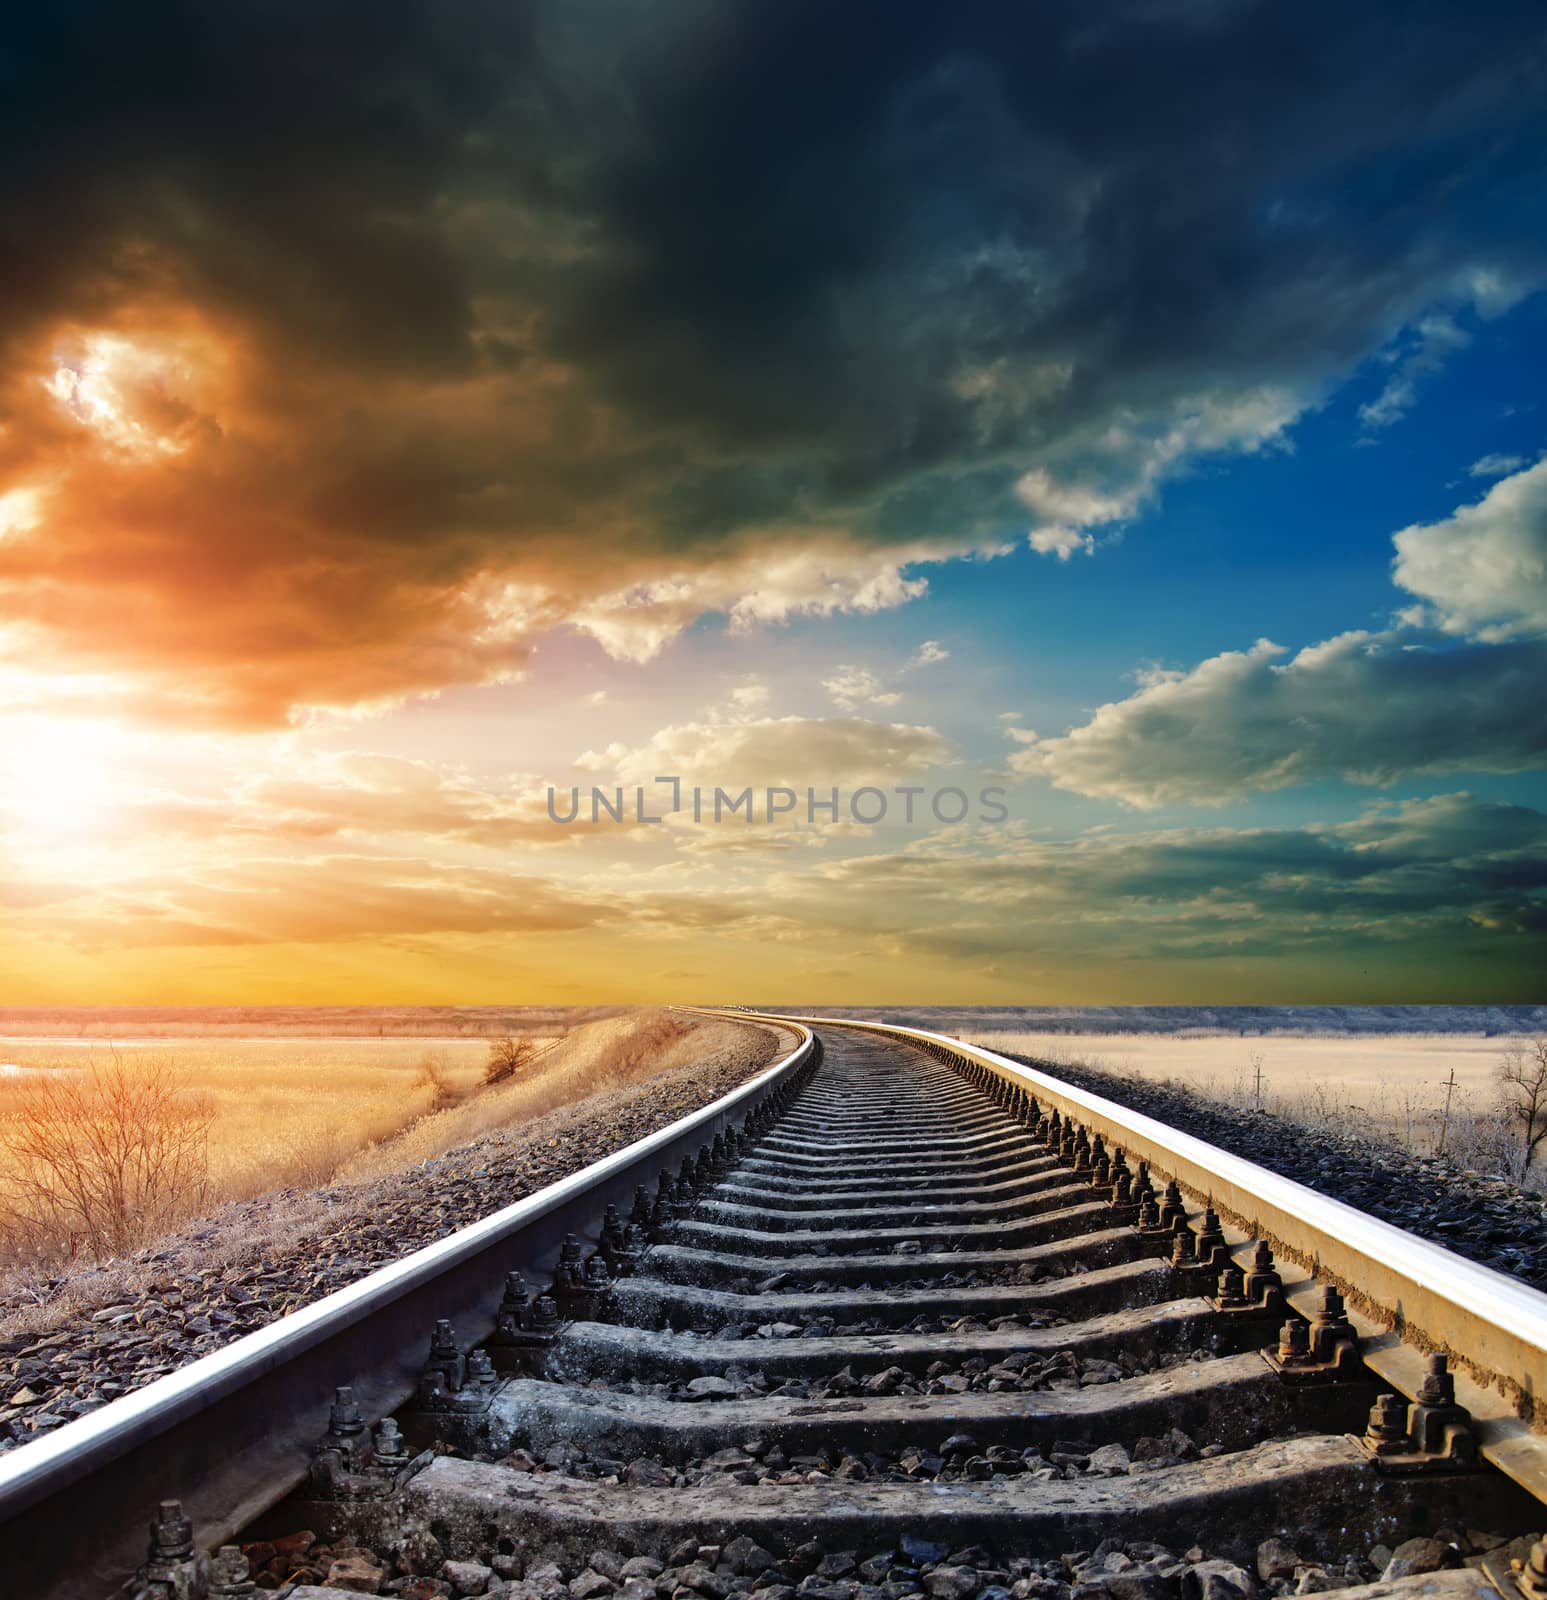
[0,1051,214,1261]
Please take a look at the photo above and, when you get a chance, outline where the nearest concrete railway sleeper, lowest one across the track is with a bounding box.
[298,1435,1541,1574]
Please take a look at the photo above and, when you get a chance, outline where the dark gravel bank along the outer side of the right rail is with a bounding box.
[1011,1056,1547,1290]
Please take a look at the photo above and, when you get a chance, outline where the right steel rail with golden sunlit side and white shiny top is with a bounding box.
[728,1010,1547,1502]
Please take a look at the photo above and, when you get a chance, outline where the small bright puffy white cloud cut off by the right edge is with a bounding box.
[1393,459,1547,640]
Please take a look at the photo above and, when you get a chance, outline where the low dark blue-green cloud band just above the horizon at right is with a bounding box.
[793,794,1547,962]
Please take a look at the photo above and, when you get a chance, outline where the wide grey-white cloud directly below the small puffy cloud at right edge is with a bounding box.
[1009,630,1547,806]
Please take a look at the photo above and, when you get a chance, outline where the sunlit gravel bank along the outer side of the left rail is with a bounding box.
[0,1029,781,1451]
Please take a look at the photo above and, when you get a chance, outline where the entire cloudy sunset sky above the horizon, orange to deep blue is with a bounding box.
[0,0,1547,1005]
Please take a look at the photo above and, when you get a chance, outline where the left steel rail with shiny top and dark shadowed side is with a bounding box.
[0,1016,816,1600]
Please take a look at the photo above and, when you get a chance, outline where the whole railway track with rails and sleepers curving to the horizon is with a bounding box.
[9,1021,1547,1600]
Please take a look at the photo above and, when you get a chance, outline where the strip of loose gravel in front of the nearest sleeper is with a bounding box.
[260,1528,1529,1600]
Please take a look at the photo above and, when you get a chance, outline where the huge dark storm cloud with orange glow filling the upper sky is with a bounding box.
[0,0,1544,718]
